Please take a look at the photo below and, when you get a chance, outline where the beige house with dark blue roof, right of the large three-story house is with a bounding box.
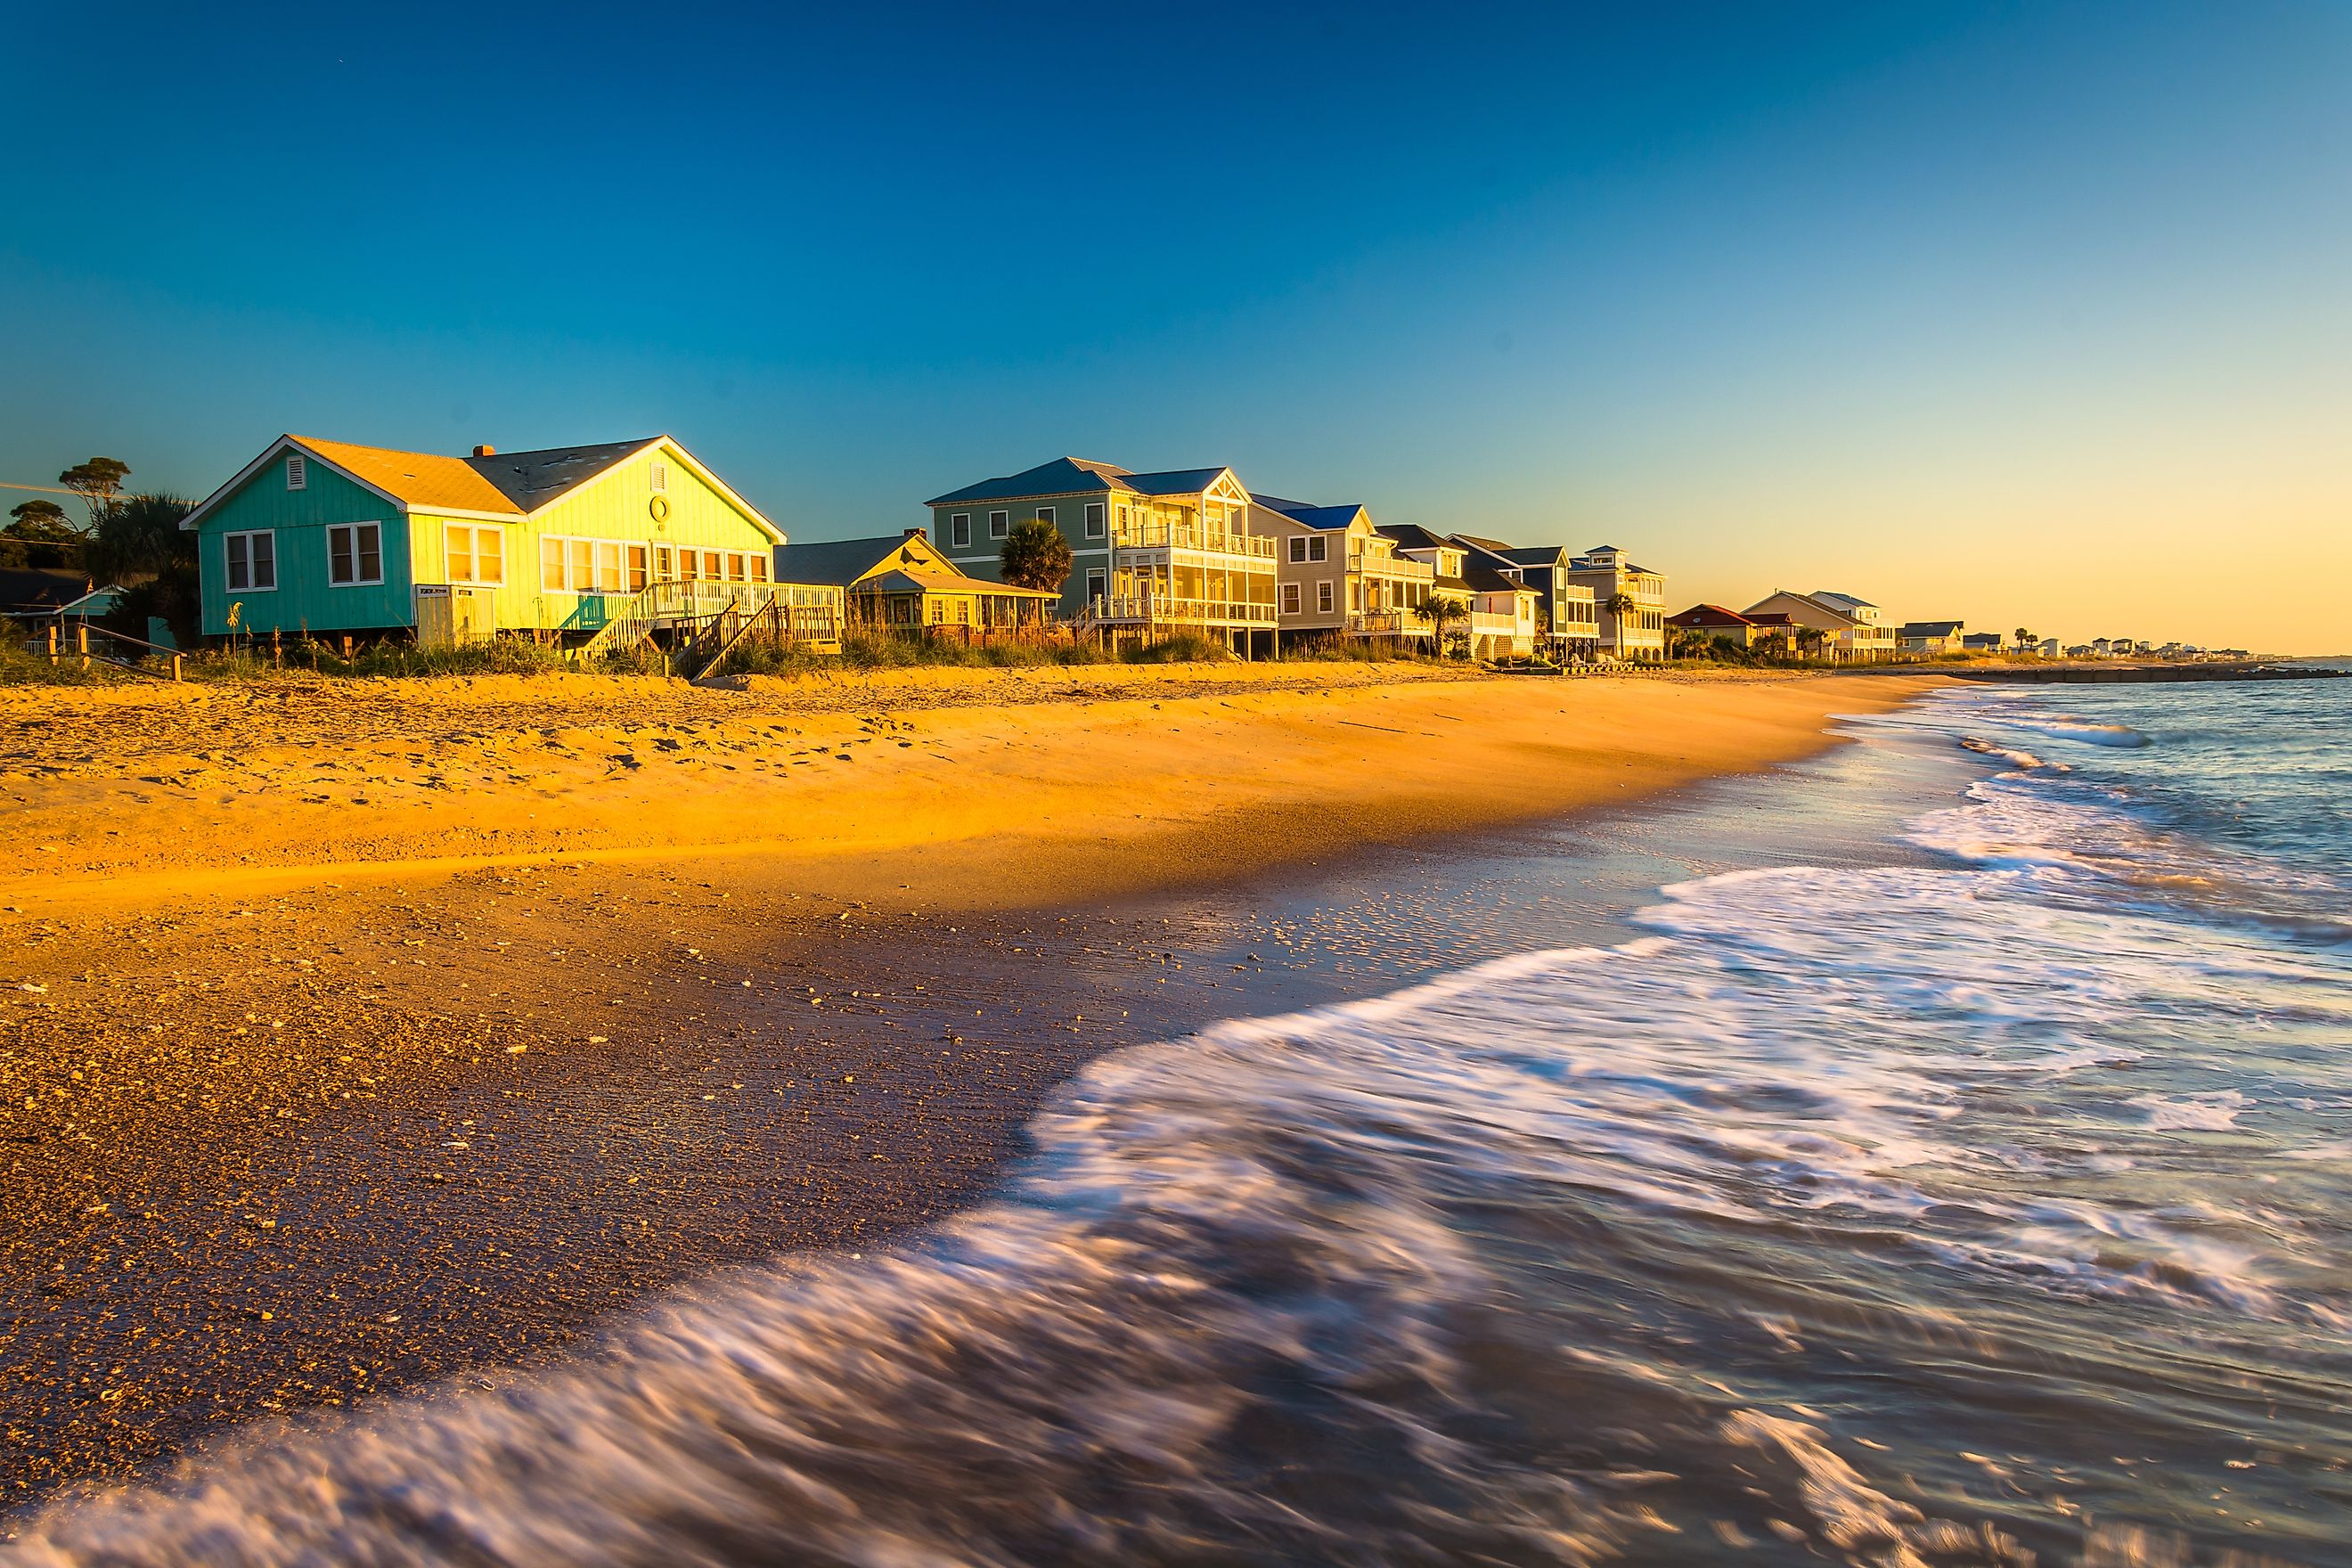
[1249,494,1437,647]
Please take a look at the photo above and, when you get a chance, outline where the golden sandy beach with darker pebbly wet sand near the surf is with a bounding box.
[0,666,1929,1502]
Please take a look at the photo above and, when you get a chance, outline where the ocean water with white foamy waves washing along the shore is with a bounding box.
[0,682,2352,1568]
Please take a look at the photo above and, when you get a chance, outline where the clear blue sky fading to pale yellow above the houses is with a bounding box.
[0,0,2352,651]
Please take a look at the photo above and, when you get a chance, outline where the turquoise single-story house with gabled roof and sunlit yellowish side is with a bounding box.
[179,435,783,641]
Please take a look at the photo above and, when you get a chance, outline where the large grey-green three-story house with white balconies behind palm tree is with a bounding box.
[925,459,1278,654]
